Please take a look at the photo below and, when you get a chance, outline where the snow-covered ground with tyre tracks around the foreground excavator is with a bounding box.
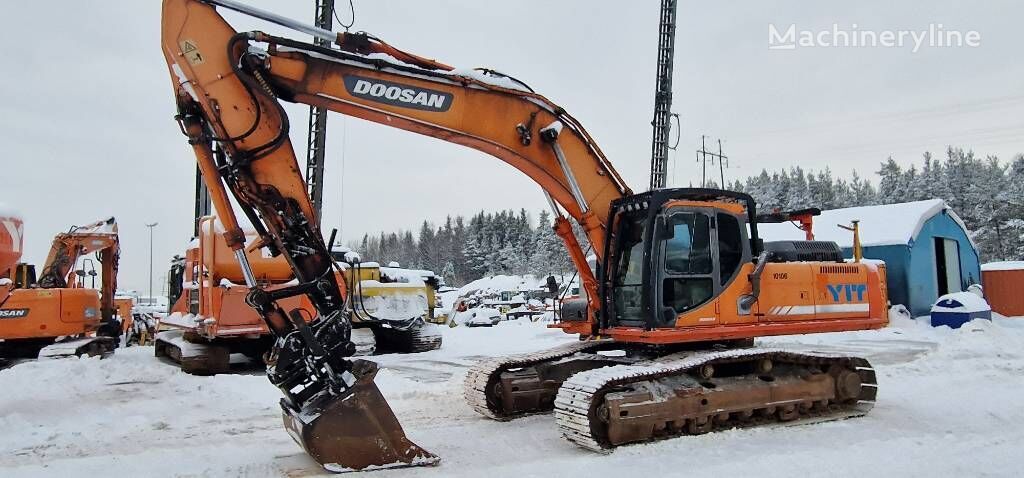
[0,318,1024,478]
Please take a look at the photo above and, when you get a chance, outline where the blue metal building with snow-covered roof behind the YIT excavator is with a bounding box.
[759,200,981,316]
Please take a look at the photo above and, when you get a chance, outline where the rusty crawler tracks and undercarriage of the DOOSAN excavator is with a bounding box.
[464,341,878,452]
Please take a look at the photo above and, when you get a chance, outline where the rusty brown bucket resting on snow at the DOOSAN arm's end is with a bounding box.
[282,360,440,473]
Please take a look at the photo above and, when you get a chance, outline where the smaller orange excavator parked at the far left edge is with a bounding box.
[0,218,122,358]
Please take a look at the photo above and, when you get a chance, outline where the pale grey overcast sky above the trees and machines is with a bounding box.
[0,0,1024,294]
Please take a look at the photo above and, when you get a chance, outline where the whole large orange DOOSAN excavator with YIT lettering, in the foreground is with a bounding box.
[162,0,887,472]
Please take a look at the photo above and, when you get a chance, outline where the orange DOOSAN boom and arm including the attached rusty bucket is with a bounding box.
[162,0,631,469]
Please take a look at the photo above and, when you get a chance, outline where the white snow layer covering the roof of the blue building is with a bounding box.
[758,200,967,248]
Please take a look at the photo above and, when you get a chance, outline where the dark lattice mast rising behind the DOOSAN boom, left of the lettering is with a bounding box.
[306,0,334,224]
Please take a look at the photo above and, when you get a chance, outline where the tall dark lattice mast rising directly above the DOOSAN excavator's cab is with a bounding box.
[650,0,679,189]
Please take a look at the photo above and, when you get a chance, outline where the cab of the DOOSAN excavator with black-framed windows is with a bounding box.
[601,188,760,330]
